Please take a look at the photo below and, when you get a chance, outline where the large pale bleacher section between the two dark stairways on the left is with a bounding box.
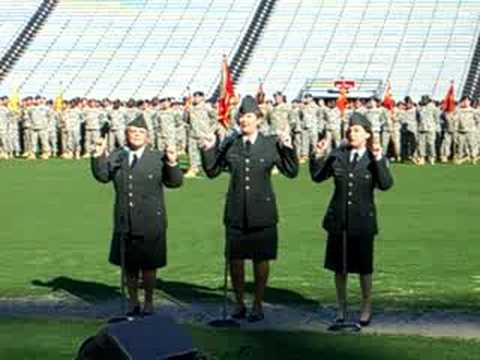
[0,0,256,99]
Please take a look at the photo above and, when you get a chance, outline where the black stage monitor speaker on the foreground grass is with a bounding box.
[76,315,197,360]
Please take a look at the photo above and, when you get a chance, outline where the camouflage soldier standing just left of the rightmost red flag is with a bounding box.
[417,95,440,165]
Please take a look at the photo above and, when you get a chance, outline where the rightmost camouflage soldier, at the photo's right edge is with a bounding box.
[453,96,480,164]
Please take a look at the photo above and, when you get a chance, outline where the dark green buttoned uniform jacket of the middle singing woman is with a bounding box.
[202,133,298,228]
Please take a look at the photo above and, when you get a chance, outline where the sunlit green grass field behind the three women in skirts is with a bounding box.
[0,160,480,310]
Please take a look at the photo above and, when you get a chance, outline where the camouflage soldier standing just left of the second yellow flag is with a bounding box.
[29,96,52,159]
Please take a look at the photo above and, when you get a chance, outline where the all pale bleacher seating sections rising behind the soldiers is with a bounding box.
[0,0,480,99]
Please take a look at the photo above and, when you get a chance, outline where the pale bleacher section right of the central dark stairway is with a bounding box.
[238,0,480,98]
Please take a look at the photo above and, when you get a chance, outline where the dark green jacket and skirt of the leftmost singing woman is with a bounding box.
[91,147,183,269]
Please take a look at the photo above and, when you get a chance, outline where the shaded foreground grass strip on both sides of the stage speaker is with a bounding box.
[0,318,480,360]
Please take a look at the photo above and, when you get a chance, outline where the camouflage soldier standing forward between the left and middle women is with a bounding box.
[185,91,218,178]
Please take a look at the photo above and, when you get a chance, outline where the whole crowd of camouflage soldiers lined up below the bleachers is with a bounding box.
[0,91,480,176]
